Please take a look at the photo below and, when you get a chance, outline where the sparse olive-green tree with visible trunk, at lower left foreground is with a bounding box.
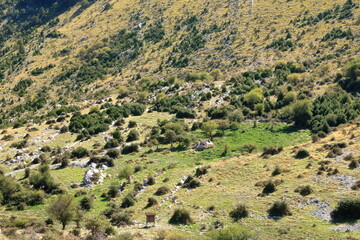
[48,195,75,230]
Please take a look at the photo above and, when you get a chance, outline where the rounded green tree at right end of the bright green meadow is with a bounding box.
[292,100,313,126]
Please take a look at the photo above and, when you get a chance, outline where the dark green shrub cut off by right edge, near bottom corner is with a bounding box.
[331,199,360,221]
